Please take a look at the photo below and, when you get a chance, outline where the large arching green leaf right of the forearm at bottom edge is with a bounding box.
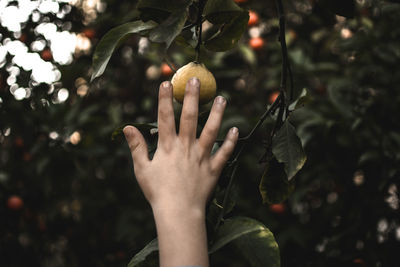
[209,217,280,267]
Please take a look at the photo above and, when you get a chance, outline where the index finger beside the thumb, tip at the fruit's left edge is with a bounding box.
[158,81,176,147]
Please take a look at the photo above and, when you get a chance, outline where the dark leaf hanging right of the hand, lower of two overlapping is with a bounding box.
[259,158,294,204]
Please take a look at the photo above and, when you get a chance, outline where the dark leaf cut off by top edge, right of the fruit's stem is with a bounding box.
[204,0,242,24]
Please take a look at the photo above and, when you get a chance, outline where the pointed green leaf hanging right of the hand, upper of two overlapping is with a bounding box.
[272,120,307,181]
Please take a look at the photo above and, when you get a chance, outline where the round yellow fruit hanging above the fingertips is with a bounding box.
[171,62,217,104]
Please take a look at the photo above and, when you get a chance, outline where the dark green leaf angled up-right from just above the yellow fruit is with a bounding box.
[205,11,249,52]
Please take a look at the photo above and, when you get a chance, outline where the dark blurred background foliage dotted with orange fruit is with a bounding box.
[0,0,400,267]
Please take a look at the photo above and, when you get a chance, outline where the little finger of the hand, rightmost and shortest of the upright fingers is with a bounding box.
[211,127,239,173]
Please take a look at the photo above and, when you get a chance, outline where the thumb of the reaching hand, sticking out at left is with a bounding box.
[123,126,150,167]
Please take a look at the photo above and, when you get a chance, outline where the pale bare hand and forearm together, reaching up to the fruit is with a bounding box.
[124,78,239,267]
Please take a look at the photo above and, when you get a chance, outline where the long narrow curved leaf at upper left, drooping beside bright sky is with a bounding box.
[90,21,157,81]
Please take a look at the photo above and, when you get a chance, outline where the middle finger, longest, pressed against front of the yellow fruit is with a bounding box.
[179,78,200,147]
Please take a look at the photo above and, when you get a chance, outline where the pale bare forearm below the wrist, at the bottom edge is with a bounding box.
[153,205,209,267]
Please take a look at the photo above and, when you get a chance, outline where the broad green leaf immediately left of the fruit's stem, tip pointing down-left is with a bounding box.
[149,7,188,48]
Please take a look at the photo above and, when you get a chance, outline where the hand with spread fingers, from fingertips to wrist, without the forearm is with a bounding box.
[123,78,238,216]
